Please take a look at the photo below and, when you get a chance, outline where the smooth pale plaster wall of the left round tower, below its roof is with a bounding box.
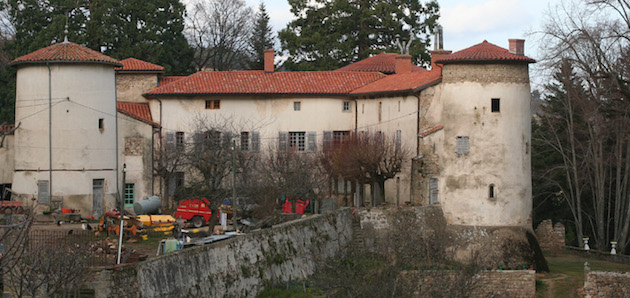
[13,63,116,214]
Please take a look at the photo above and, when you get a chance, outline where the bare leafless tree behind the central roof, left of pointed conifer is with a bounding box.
[186,0,253,70]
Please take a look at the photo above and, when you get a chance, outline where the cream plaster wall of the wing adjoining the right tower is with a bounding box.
[357,95,418,204]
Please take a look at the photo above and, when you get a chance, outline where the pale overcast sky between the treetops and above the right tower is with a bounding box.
[246,0,559,58]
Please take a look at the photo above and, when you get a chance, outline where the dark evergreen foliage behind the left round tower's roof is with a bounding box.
[8,0,192,74]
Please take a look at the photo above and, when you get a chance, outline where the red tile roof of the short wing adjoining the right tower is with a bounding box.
[350,69,442,95]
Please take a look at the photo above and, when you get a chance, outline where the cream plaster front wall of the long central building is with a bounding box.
[152,96,354,150]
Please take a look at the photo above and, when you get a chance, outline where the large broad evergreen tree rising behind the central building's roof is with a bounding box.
[278,0,439,70]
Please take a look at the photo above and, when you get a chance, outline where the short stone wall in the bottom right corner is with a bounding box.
[584,270,630,297]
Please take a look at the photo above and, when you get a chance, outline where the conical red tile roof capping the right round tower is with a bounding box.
[435,40,536,64]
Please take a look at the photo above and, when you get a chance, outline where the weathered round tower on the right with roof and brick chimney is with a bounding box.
[436,39,535,226]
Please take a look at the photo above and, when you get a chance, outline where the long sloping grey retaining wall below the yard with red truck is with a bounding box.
[92,208,353,297]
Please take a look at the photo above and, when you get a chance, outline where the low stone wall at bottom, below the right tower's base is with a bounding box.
[400,270,536,297]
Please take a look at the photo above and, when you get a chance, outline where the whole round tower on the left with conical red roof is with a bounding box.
[10,41,121,216]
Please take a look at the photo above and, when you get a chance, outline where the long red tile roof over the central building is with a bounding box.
[144,70,384,97]
